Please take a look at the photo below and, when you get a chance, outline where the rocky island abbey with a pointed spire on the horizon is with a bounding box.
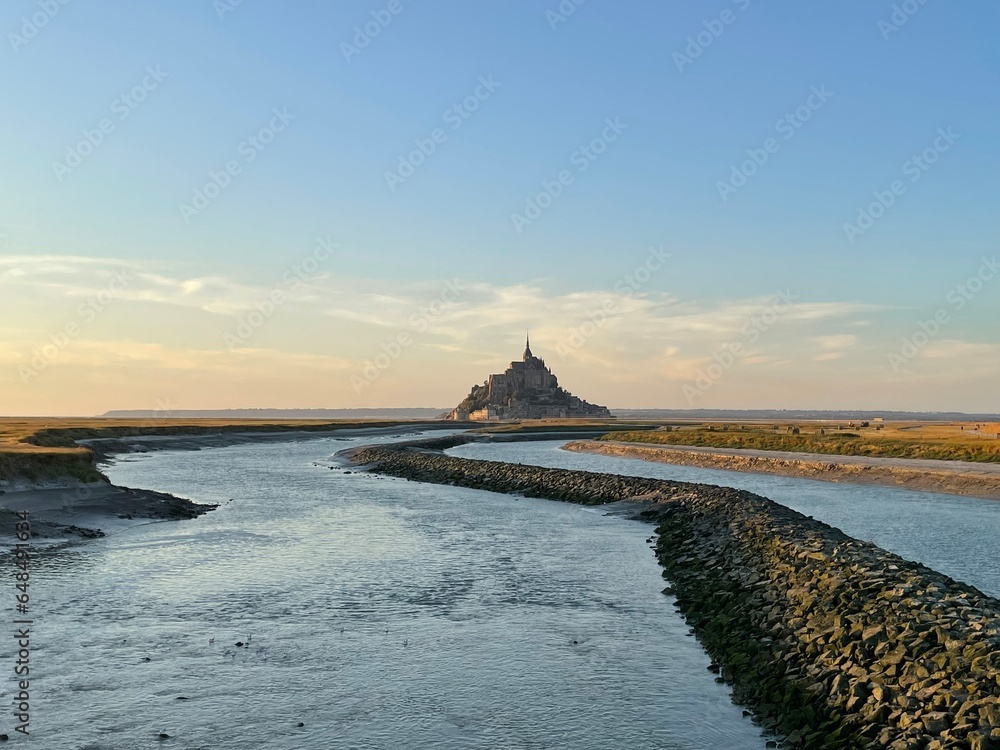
[448,337,611,421]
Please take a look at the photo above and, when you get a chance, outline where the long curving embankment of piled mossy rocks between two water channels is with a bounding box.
[348,438,1000,750]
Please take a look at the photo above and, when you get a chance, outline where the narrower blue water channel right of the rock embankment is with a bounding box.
[449,440,1000,596]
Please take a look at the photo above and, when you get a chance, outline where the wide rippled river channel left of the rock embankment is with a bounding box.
[11,438,768,750]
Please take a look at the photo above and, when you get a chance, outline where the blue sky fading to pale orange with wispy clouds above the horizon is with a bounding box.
[0,0,1000,415]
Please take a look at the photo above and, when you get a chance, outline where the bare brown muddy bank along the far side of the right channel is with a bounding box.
[563,440,1000,500]
